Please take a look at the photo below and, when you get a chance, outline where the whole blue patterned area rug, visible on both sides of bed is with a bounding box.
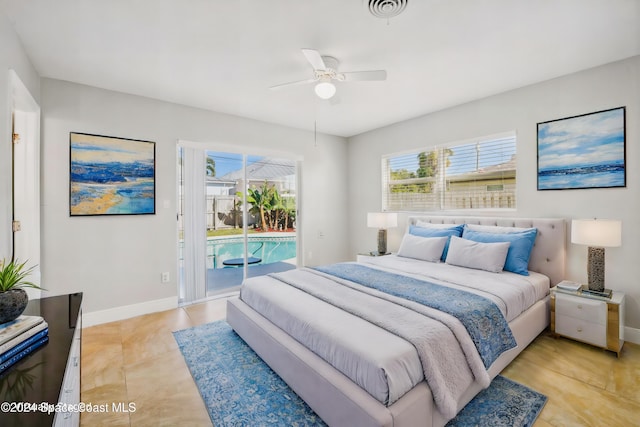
[173,321,547,427]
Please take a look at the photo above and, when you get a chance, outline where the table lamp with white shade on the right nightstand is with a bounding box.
[571,219,622,292]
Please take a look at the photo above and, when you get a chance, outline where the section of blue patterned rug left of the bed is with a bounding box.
[173,321,326,427]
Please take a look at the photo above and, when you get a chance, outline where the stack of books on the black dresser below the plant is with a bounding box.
[0,315,49,374]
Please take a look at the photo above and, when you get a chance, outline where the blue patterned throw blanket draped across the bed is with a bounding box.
[315,263,517,369]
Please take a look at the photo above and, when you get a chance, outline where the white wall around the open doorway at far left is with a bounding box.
[0,13,40,259]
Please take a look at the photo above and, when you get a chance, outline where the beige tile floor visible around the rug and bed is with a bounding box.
[81,299,640,427]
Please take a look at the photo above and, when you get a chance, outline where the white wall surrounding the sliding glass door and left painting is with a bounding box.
[41,79,348,313]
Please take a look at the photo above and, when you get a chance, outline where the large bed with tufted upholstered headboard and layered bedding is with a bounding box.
[227,216,565,427]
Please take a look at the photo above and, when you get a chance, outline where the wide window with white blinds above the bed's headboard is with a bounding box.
[382,132,516,211]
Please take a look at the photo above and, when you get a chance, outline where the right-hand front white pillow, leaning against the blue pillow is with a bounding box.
[445,236,509,273]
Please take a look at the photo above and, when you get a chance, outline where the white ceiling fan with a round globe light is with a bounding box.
[269,49,387,99]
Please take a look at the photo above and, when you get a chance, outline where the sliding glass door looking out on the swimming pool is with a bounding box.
[178,145,298,303]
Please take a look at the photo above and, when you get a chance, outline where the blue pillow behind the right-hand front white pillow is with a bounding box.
[462,228,538,276]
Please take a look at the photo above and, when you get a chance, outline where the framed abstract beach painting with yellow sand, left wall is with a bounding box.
[69,132,155,216]
